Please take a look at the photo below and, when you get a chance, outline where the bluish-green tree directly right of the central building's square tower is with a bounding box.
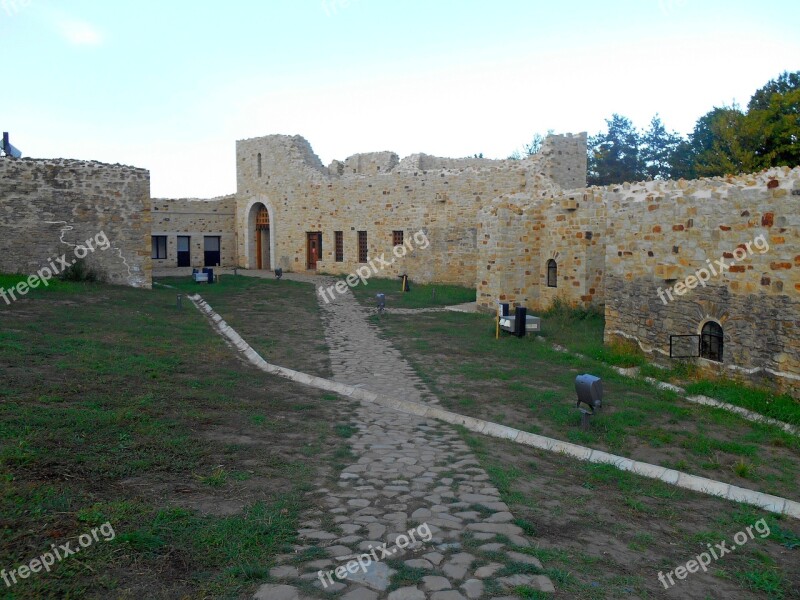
[588,113,643,185]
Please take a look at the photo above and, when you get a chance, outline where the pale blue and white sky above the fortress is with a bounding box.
[0,0,800,197]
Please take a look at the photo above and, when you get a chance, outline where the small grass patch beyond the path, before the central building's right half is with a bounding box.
[351,278,475,309]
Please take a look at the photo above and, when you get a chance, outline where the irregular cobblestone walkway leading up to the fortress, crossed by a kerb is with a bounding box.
[254,278,553,600]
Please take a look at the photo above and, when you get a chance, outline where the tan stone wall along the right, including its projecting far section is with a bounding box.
[477,167,800,391]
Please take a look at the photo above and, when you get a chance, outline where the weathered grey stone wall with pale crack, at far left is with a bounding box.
[0,157,152,288]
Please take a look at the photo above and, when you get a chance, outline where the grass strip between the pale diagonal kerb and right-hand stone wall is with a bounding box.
[360,307,800,498]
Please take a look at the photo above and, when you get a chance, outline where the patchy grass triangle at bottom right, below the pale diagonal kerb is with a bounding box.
[462,430,800,600]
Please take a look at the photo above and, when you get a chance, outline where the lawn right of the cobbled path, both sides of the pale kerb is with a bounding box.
[350,292,800,599]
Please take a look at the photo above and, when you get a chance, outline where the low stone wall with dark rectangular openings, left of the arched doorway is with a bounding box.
[152,194,237,267]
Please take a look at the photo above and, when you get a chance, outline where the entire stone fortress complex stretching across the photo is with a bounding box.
[0,134,800,392]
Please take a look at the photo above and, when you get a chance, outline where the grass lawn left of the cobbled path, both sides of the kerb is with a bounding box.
[0,276,347,598]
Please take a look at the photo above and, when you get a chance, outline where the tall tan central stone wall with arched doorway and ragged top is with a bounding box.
[236,134,586,287]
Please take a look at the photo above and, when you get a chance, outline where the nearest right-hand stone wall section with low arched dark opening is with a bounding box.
[605,167,800,390]
